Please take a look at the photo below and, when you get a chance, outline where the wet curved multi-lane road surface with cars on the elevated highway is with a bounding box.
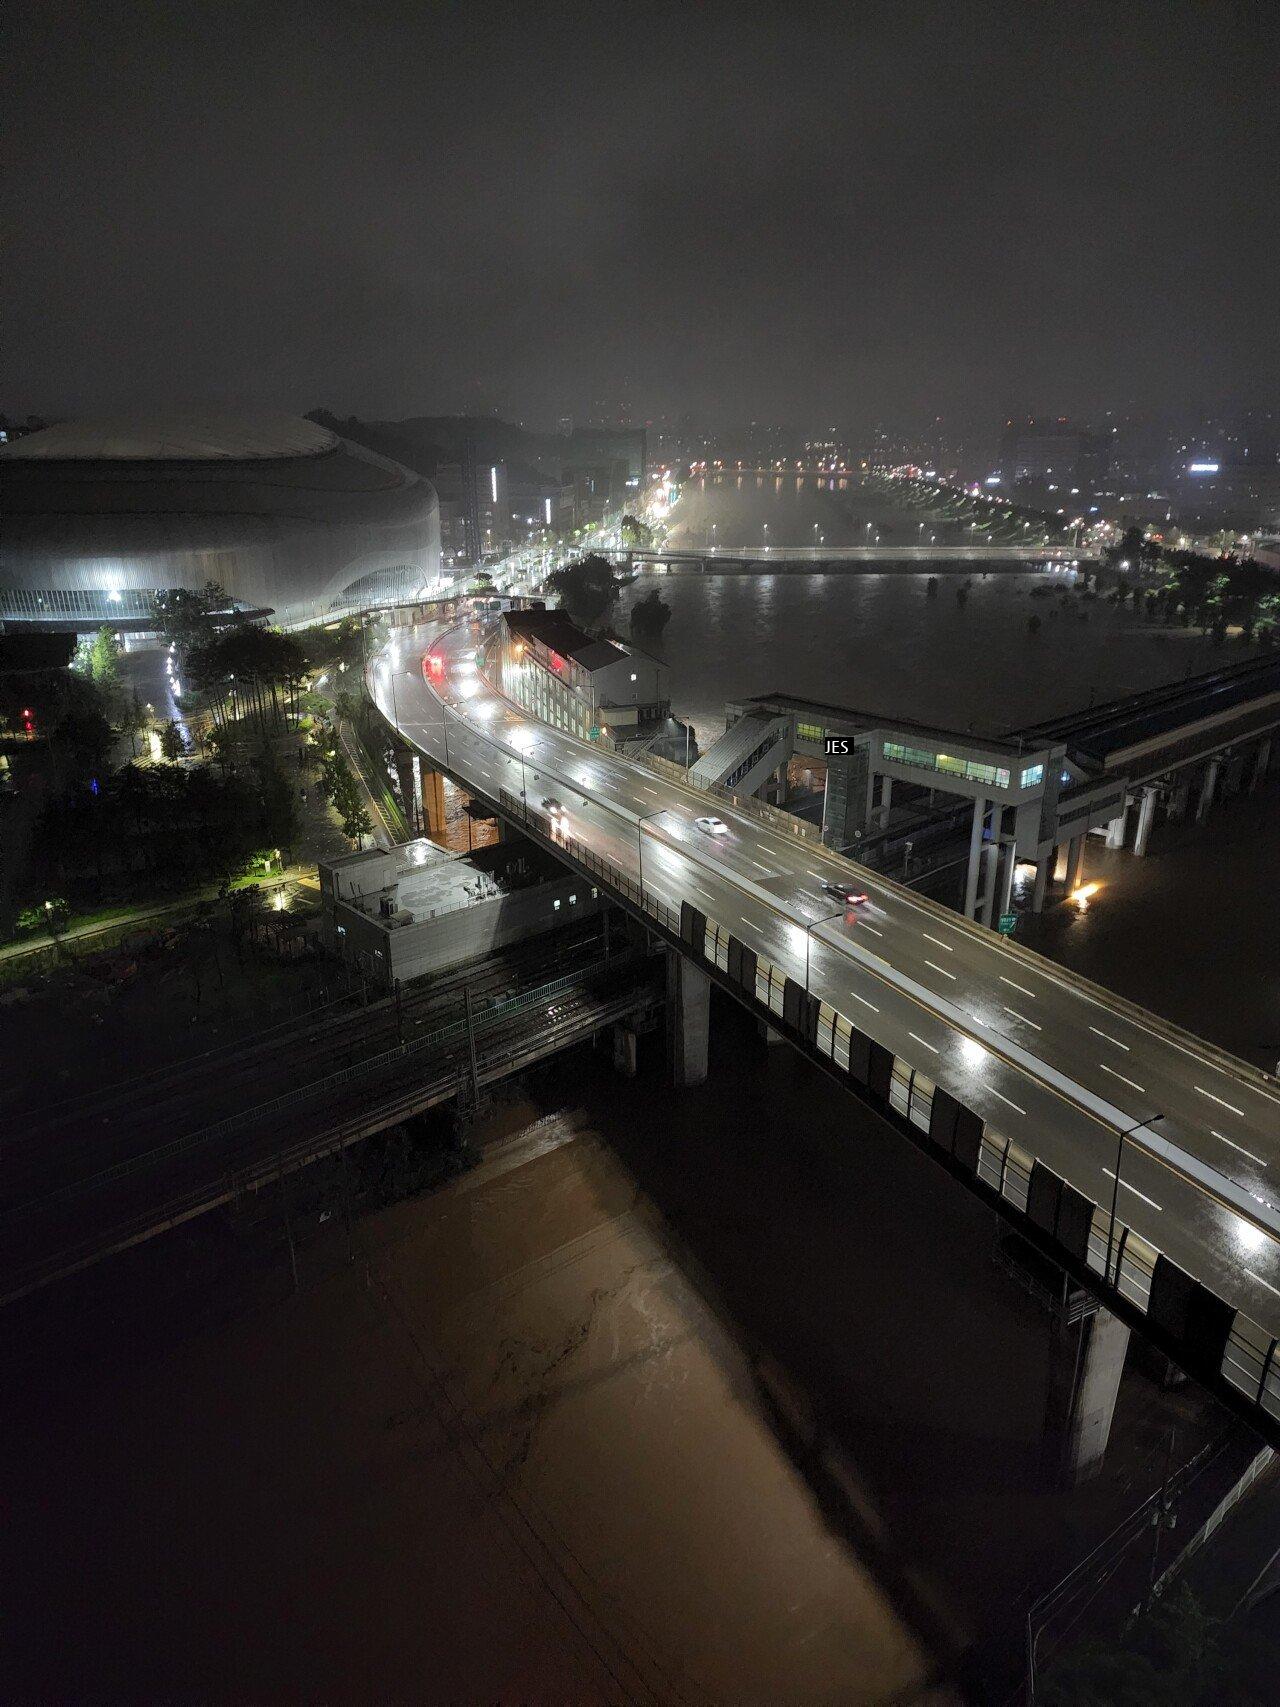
[369,625,1280,1365]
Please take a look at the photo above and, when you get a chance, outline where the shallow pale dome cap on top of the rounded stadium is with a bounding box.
[0,408,340,463]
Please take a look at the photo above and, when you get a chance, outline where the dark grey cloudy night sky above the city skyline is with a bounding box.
[0,0,1280,434]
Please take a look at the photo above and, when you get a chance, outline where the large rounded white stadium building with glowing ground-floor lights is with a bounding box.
[0,410,440,630]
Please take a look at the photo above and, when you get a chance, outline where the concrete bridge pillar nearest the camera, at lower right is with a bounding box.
[1044,1309,1128,1487]
